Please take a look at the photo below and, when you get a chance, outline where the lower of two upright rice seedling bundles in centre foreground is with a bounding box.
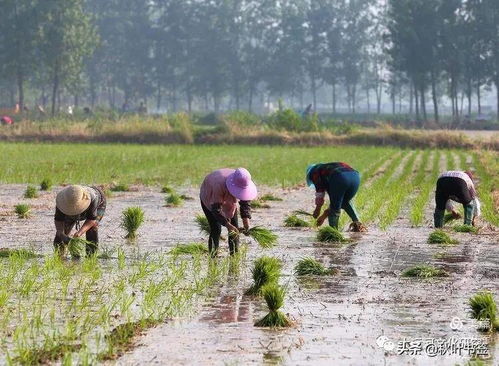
[255,283,292,328]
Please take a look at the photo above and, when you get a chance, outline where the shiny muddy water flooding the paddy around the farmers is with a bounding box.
[0,185,499,365]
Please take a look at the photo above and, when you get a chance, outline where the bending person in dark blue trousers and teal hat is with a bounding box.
[306,162,366,232]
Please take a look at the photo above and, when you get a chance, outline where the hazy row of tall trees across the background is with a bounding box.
[0,0,499,121]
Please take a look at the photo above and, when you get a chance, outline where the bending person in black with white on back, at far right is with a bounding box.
[433,171,480,228]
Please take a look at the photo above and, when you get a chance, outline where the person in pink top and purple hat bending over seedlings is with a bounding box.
[200,168,258,256]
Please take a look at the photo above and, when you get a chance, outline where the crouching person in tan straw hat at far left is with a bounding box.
[54,185,106,255]
